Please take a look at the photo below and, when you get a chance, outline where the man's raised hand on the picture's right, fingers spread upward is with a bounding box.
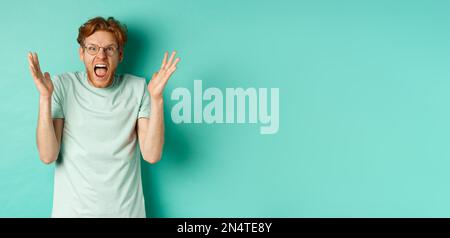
[148,51,180,100]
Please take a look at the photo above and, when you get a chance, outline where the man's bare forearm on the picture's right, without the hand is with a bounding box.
[141,99,164,164]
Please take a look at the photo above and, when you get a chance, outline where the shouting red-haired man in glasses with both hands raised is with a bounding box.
[28,17,180,217]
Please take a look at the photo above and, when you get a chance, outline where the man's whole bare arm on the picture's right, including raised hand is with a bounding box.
[137,52,180,164]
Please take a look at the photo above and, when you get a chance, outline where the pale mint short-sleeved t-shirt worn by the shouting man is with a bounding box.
[52,72,150,217]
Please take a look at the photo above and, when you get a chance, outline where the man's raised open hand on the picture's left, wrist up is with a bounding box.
[28,52,53,98]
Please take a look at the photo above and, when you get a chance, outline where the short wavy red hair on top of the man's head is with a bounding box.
[77,17,127,49]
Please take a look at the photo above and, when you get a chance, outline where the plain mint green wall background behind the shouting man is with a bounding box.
[0,0,450,217]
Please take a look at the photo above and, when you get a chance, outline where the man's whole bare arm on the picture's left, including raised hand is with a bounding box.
[28,53,64,164]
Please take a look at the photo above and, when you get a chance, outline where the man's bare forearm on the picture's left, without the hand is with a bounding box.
[36,97,59,164]
